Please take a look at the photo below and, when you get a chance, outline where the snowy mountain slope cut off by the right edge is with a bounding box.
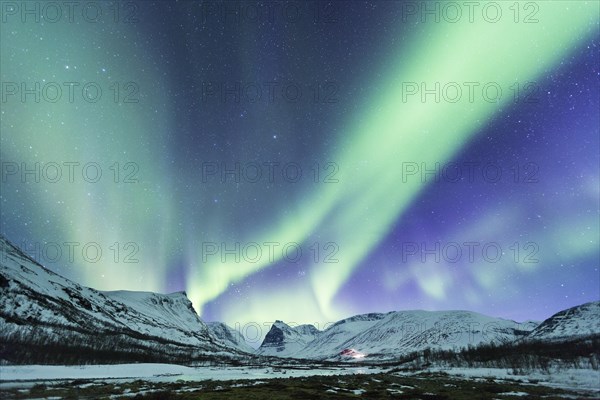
[526,301,600,341]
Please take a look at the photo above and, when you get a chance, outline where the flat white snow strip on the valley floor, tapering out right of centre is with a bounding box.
[0,364,385,388]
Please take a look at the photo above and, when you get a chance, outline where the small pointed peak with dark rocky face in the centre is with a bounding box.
[256,321,319,357]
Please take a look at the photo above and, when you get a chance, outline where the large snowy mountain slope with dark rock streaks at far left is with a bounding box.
[0,236,239,361]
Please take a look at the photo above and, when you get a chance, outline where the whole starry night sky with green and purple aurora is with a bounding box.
[0,1,600,342]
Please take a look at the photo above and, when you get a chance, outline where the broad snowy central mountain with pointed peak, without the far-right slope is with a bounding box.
[261,311,537,360]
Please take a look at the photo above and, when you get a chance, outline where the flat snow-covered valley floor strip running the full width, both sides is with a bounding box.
[0,364,600,396]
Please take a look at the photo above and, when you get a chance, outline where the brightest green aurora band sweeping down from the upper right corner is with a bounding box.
[187,2,598,322]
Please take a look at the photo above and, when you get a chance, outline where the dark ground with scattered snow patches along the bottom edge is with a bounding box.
[0,373,598,400]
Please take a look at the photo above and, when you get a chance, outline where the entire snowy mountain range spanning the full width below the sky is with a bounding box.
[0,235,600,363]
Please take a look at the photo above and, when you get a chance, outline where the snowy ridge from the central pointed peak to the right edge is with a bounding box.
[257,301,600,361]
